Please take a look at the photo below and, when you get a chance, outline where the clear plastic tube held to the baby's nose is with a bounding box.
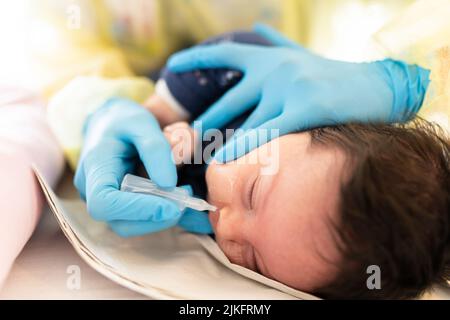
[120,174,217,211]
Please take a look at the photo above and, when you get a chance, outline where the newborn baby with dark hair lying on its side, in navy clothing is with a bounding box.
[145,33,450,299]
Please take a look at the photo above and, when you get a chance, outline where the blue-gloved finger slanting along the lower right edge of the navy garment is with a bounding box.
[196,77,259,130]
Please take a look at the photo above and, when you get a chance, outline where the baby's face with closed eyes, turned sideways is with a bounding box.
[206,132,345,291]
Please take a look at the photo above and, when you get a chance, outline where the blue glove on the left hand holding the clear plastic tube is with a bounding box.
[75,98,210,236]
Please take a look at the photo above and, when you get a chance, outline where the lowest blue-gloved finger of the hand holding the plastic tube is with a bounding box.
[108,218,179,238]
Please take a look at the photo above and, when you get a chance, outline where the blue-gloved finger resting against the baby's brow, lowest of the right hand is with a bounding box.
[214,116,286,163]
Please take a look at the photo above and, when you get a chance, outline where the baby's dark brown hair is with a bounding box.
[311,119,450,299]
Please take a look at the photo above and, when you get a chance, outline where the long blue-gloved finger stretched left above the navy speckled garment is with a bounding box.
[167,42,260,72]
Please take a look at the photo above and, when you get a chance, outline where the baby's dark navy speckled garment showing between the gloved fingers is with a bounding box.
[161,31,272,198]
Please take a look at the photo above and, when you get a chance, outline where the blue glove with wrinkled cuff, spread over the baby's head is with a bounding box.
[168,25,429,161]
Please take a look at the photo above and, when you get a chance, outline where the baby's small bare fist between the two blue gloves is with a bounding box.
[163,121,197,165]
